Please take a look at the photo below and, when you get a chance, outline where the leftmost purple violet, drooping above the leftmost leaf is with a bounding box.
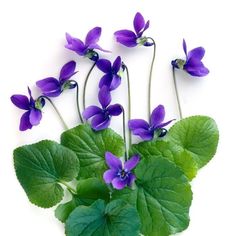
[11,87,45,131]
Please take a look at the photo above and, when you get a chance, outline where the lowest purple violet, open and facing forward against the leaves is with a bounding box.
[103,152,140,189]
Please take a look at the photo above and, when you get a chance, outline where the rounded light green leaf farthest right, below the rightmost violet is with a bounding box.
[167,116,219,168]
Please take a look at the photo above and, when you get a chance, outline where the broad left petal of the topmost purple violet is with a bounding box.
[114,30,137,47]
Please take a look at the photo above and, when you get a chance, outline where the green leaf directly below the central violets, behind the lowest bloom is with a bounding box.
[61,124,124,178]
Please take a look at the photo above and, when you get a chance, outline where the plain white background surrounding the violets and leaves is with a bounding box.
[0,0,236,236]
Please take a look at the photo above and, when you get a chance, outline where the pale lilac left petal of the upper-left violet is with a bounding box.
[65,33,87,56]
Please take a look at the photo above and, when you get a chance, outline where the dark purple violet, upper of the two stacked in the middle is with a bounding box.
[97,56,121,91]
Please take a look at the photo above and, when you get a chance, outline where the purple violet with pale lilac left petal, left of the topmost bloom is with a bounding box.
[65,27,109,61]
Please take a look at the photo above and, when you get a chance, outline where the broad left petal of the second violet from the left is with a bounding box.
[36,77,61,97]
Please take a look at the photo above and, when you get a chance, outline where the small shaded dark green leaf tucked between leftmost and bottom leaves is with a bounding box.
[55,178,110,222]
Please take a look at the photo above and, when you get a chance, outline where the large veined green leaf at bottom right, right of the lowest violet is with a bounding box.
[113,157,192,236]
